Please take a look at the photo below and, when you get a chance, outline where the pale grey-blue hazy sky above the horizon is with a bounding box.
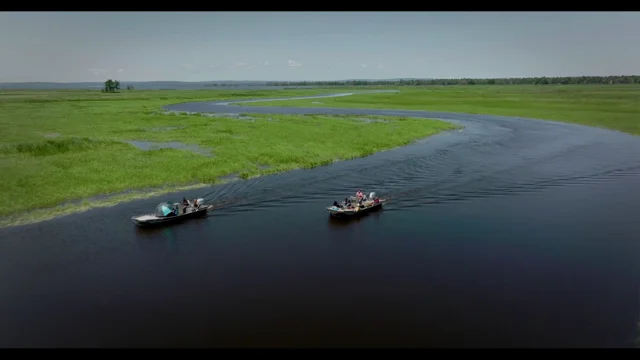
[0,12,640,82]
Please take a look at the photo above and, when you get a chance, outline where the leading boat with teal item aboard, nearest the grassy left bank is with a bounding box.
[131,199,213,227]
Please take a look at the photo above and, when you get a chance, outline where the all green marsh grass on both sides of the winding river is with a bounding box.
[0,84,640,226]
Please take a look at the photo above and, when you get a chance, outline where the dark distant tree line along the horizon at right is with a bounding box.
[267,75,640,86]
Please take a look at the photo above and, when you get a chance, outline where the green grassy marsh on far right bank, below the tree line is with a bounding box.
[242,85,640,135]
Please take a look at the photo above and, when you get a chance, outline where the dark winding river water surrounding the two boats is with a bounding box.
[0,94,640,347]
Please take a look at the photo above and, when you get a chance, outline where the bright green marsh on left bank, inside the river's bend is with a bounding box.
[0,89,453,226]
